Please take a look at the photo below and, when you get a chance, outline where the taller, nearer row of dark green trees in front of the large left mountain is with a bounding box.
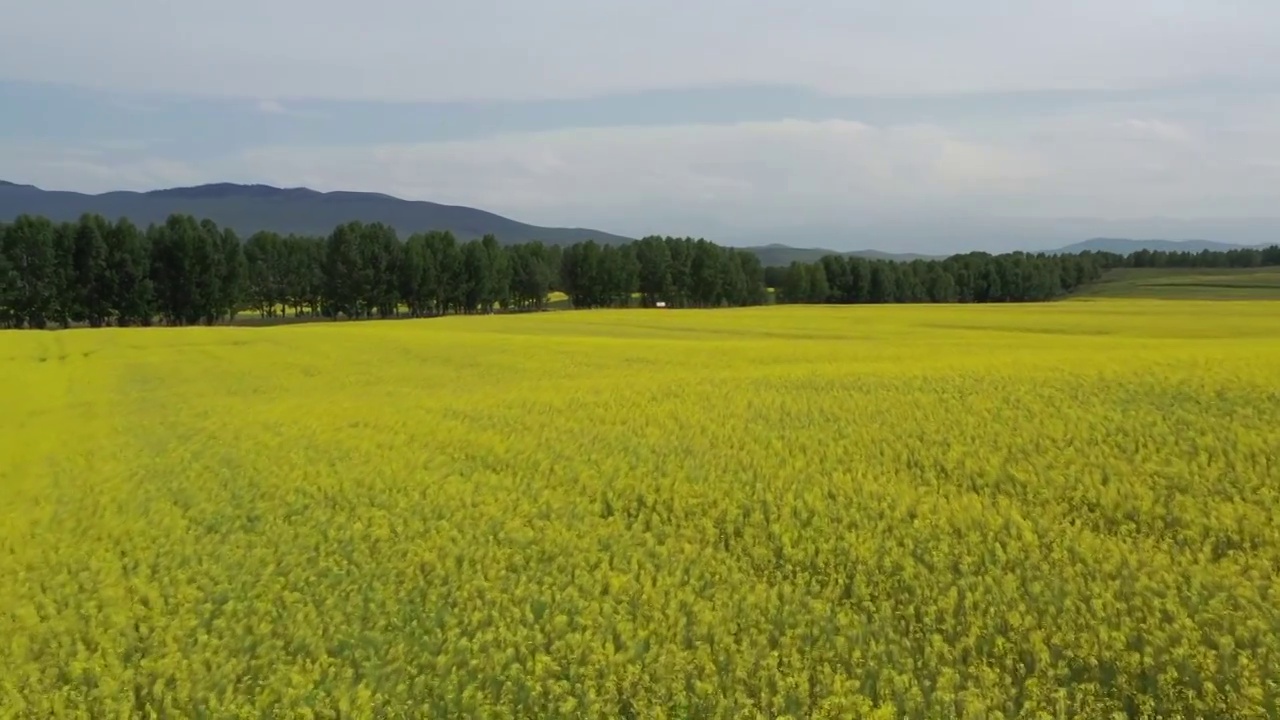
[0,214,768,328]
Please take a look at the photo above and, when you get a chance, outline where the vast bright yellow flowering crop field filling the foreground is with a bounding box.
[0,300,1280,720]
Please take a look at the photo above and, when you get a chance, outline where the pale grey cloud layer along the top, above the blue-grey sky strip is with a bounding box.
[0,0,1280,100]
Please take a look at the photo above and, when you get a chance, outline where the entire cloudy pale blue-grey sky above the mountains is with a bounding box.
[0,0,1280,252]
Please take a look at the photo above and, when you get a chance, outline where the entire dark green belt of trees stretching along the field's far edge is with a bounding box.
[0,210,1280,329]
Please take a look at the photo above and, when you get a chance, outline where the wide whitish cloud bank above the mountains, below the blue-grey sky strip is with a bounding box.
[0,104,1280,247]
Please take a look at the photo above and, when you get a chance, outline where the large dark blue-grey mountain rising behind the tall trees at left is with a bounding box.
[0,181,630,245]
